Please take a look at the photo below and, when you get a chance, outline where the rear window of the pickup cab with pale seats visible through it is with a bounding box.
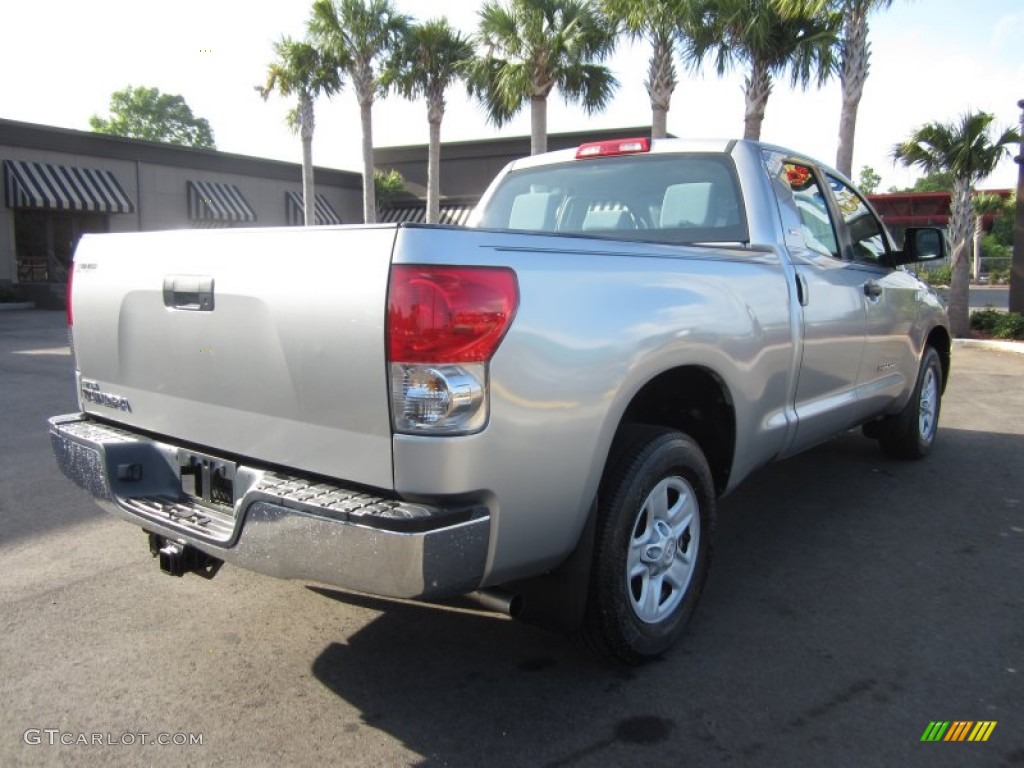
[479,154,749,243]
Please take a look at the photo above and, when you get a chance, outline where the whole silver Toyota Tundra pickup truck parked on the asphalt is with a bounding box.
[50,138,950,663]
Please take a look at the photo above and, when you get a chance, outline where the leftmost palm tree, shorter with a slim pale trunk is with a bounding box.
[256,37,342,226]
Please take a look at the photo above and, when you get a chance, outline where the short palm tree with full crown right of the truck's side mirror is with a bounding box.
[892,112,1020,337]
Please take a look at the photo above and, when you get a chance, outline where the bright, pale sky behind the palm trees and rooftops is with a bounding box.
[0,0,1024,190]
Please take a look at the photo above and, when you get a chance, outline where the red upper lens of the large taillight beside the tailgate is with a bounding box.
[387,264,519,364]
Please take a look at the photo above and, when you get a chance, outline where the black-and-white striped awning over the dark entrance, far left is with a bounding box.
[3,160,135,213]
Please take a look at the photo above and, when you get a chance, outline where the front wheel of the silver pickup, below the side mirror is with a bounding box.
[879,347,943,459]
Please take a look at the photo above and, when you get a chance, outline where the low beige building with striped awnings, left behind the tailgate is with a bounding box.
[0,120,362,306]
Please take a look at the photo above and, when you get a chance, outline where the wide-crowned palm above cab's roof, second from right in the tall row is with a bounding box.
[690,0,841,139]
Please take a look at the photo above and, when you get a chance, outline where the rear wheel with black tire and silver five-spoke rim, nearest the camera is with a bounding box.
[581,425,715,664]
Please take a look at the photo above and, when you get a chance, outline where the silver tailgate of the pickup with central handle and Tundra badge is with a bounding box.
[73,226,397,488]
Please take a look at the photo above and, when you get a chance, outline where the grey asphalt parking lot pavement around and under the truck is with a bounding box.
[0,311,1024,768]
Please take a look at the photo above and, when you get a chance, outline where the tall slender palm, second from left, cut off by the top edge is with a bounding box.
[309,0,409,224]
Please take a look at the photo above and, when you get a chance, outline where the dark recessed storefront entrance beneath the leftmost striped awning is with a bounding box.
[14,208,110,283]
